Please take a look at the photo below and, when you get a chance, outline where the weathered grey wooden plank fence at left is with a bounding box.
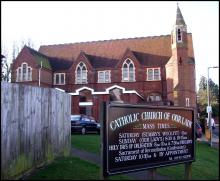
[1,82,71,179]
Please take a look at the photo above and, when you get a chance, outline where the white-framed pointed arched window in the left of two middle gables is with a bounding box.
[75,62,87,84]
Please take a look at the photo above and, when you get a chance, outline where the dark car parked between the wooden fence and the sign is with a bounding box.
[71,115,100,134]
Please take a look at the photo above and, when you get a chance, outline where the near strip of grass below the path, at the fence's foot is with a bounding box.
[25,157,131,180]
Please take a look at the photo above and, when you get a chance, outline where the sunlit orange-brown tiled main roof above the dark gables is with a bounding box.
[39,33,194,61]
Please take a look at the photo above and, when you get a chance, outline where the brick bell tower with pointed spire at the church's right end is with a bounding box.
[166,4,196,107]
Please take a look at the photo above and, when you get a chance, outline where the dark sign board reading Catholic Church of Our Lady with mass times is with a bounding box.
[102,104,195,176]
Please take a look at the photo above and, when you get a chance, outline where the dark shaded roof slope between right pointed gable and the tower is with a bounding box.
[132,51,170,67]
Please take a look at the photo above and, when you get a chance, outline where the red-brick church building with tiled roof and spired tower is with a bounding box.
[12,6,196,120]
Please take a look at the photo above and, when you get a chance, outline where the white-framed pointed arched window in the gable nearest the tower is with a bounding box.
[122,59,135,82]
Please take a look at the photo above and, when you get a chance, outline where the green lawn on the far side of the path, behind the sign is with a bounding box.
[72,134,219,180]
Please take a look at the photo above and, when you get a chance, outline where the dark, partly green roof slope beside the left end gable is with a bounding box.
[26,46,73,71]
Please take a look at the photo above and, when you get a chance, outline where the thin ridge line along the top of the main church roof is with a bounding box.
[40,34,171,47]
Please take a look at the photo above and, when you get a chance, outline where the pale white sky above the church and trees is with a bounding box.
[1,1,219,89]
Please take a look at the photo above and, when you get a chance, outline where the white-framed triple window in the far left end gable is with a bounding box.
[16,63,32,82]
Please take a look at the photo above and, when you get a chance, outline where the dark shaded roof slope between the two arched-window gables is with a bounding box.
[85,54,119,68]
